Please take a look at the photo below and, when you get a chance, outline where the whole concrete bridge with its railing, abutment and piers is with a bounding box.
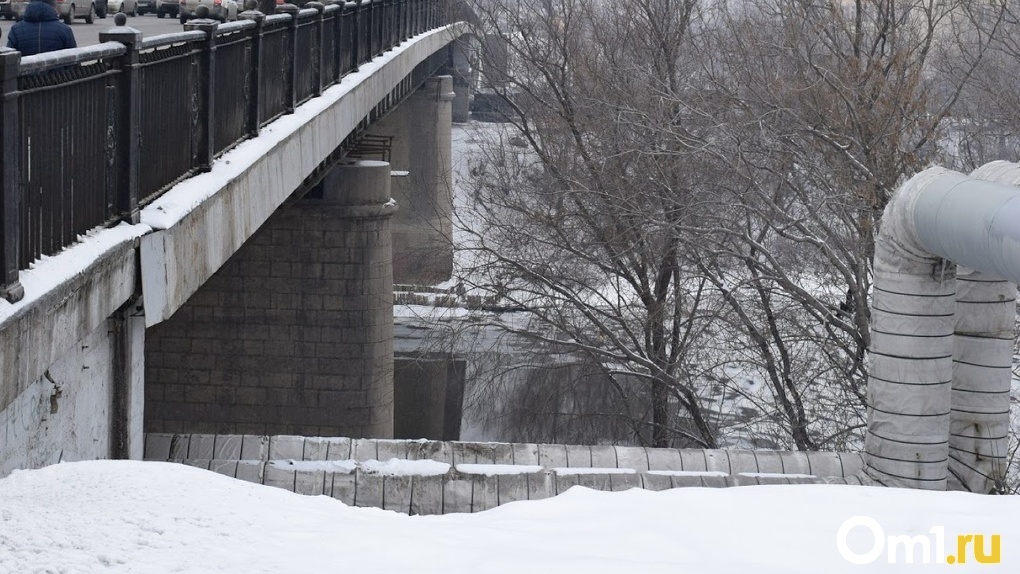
[0,0,470,476]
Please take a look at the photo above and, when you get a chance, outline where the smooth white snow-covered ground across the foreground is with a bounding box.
[0,461,1020,574]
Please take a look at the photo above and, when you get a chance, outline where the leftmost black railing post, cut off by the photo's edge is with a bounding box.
[0,48,24,303]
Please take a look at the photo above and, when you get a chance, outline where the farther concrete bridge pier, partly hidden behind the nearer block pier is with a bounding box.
[369,75,454,284]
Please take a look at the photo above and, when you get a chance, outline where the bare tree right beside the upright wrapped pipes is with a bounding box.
[681,0,1002,449]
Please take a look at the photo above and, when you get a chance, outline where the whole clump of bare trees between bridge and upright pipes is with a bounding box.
[463,0,1007,449]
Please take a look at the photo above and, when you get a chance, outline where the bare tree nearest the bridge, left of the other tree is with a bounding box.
[459,0,717,447]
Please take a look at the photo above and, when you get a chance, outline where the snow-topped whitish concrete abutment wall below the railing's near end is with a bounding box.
[0,225,146,476]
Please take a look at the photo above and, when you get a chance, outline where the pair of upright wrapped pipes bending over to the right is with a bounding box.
[865,164,1020,492]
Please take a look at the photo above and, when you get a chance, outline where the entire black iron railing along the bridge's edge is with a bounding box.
[0,0,445,302]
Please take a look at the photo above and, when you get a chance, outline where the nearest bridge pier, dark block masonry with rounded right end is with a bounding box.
[145,195,393,436]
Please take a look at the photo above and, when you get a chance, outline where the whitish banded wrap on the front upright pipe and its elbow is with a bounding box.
[865,167,956,490]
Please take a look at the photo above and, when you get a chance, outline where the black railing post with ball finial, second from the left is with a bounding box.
[99,13,142,223]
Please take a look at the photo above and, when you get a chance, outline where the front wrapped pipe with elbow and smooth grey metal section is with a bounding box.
[865,167,1020,490]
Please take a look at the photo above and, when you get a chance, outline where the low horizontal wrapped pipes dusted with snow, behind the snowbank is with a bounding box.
[146,433,864,515]
